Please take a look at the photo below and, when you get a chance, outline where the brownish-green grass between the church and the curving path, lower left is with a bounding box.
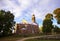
[0,34,40,41]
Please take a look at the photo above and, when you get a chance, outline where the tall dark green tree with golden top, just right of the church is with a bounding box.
[42,13,53,34]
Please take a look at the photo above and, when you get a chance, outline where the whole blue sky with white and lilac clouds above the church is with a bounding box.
[0,0,60,25]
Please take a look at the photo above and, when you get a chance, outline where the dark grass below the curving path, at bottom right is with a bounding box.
[25,34,60,41]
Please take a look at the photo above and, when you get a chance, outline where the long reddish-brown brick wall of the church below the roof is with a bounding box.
[16,24,39,34]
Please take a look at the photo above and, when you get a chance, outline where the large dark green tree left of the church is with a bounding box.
[0,10,15,35]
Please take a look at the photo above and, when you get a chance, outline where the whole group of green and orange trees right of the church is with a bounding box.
[42,8,60,34]
